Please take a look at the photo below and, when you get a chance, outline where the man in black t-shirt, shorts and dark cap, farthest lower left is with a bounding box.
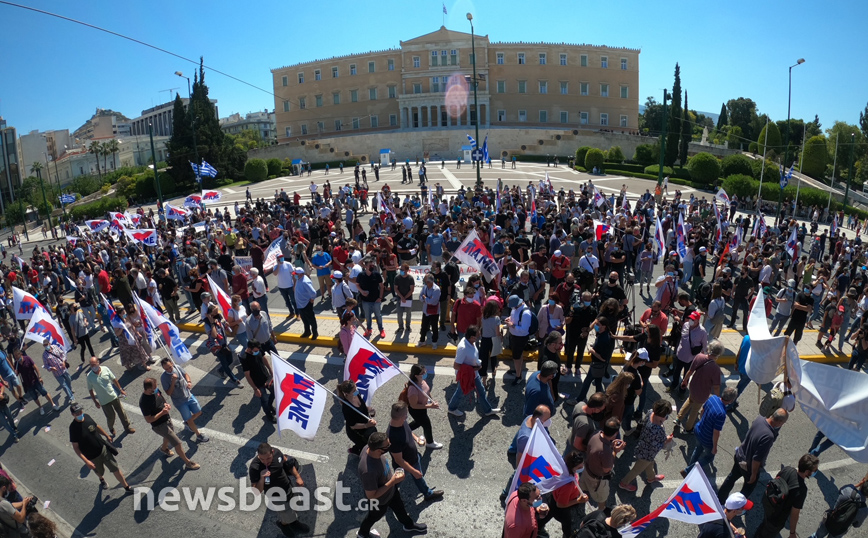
[69,403,133,493]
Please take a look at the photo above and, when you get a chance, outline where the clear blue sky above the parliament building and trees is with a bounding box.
[0,0,868,133]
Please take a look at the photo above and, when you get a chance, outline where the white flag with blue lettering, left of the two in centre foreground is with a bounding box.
[271,353,329,441]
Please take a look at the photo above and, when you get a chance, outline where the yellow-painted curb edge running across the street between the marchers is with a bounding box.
[177,323,850,366]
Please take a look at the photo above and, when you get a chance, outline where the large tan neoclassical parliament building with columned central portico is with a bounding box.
[269,27,640,162]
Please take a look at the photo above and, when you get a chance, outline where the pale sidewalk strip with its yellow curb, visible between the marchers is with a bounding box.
[178,294,852,366]
